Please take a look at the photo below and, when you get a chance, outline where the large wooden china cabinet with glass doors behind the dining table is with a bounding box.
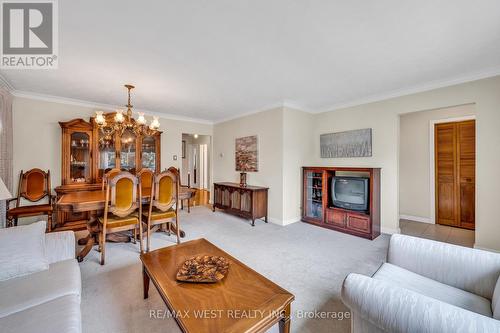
[53,112,161,231]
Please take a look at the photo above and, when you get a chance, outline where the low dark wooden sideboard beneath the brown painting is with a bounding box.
[213,183,269,226]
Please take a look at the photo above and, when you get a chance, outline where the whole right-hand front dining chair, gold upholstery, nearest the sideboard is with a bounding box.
[142,171,181,252]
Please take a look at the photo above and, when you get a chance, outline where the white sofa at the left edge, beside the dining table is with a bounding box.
[0,231,81,333]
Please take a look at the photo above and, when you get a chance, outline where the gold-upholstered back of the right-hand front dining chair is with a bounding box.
[152,171,179,212]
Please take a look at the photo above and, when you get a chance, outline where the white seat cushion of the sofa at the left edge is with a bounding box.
[0,259,81,318]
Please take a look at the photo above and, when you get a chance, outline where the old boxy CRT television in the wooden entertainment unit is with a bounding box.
[330,177,370,211]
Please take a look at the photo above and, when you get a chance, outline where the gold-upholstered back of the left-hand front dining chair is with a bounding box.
[105,171,141,217]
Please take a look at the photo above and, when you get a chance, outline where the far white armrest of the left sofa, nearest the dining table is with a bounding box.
[45,231,76,264]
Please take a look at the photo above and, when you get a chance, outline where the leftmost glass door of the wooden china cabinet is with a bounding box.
[69,132,91,183]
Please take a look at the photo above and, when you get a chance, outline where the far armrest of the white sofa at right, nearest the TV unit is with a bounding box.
[387,235,500,299]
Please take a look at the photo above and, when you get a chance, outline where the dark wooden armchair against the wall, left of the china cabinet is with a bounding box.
[6,168,55,232]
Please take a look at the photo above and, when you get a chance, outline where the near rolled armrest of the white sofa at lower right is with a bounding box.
[342,274,500,333]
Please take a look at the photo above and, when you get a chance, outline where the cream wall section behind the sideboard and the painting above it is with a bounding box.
[213,108,283,224]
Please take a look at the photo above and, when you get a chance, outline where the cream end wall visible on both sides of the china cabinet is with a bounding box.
[12,97,213,189]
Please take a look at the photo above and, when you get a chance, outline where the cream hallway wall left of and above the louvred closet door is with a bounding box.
[399,104,476,222]
